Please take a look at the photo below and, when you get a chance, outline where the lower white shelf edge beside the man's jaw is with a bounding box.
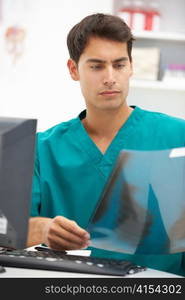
[130,79,185,92]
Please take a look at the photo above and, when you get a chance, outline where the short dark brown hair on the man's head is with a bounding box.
[67,13,134,63]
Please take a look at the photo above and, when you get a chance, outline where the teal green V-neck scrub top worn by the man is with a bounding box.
[31,107,185,276]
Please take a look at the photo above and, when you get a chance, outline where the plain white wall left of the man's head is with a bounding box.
[0,0,112,130]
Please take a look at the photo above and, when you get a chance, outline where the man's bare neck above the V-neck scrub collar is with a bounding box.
[82,105,133,139]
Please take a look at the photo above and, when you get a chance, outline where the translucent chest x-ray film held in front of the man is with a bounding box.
[88,148,185,254]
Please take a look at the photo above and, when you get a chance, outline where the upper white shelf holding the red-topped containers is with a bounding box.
[133,31,185,42]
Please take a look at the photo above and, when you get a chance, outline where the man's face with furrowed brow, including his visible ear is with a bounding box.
[68,37,132,110]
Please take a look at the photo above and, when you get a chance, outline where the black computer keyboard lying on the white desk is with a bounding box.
[0,249,146,276]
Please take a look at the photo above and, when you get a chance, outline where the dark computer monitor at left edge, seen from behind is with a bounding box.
[0,117,37,249]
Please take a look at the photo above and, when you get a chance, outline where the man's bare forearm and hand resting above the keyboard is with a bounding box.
[27,216,90,250]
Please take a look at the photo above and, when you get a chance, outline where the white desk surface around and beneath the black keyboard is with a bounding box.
[0,247,182,278]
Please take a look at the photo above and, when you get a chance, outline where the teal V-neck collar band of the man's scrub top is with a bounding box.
[75,106,142,167]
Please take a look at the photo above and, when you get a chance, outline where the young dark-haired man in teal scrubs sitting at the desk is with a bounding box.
[28,14,185,275]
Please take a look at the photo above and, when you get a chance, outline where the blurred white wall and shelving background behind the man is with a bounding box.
[0,0,185,131]
